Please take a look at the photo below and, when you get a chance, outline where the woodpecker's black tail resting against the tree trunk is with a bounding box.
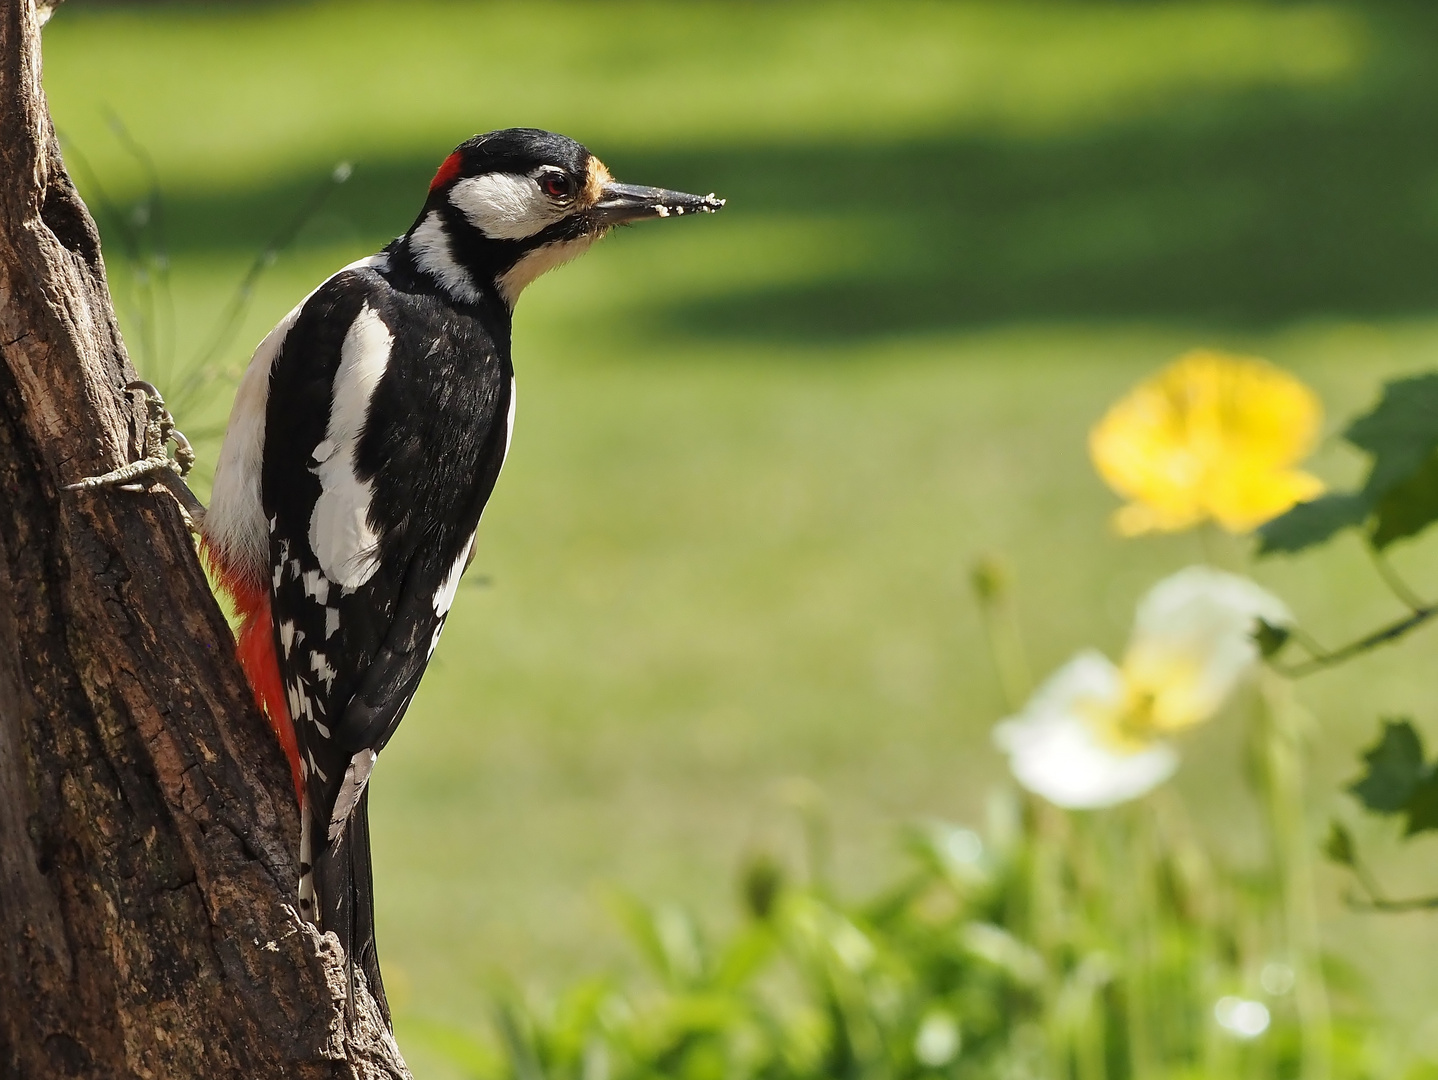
[315,790,393,1030]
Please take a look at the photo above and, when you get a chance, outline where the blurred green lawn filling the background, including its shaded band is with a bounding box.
[33,0,1438,1074]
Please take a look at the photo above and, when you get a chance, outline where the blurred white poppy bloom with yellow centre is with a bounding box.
[994,567,1291,810]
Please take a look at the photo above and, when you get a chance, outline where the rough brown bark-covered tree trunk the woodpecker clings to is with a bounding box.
[0,0,408,1080]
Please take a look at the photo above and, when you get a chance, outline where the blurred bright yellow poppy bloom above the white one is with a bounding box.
[1089,349,1323,536]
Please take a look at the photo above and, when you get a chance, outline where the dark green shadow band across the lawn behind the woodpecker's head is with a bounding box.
[98,4,1438,341]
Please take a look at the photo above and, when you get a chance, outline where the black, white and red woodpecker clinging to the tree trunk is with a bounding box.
[76,128,723,1018]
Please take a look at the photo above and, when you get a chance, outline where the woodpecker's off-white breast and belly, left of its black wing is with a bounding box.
[201,255,390,587]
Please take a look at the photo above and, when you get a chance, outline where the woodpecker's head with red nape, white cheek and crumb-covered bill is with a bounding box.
[408,128,723,308]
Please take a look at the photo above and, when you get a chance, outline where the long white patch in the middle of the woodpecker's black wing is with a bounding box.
[306,305,394,592]
